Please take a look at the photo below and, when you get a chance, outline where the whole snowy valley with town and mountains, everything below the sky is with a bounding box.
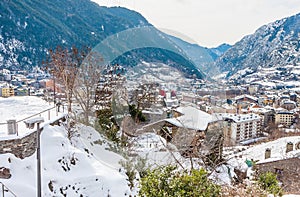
[0,0,300,197]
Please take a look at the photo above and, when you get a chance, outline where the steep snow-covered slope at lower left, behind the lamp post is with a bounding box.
[0,126,130,197]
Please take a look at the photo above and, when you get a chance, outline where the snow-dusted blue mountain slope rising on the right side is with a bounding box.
[215,14,300,76]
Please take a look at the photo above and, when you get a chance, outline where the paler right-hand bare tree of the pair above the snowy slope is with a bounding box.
[73,52,103,125]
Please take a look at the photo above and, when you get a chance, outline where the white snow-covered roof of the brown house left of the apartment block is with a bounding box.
[165,106,214,131]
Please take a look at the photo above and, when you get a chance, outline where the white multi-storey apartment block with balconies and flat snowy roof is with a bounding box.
[222,113,262,143]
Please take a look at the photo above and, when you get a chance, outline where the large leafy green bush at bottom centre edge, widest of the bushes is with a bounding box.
[139,166,220,197]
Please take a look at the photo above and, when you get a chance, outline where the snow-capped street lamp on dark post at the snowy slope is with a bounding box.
[24,117,44,197]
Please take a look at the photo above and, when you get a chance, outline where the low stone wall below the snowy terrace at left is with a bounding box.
[0,117,65,159]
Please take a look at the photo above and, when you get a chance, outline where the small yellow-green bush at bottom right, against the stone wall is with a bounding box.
[258,172,283,196]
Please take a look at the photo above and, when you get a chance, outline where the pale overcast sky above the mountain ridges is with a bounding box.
[93,0,300,47]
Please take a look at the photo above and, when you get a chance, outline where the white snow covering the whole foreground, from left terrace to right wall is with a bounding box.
[0,97,300,197]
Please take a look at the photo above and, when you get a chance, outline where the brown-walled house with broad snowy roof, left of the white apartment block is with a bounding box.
[134,106,223,157]
